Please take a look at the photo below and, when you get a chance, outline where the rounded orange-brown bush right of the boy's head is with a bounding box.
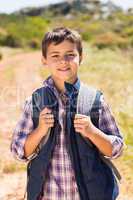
[93,32,128,49]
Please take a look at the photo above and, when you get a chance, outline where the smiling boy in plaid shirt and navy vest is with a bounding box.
[11,27,123,200]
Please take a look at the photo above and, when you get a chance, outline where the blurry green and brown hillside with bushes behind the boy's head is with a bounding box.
[0,1,133,49]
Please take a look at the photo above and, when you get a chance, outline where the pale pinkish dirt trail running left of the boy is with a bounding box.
[0,49,42,200]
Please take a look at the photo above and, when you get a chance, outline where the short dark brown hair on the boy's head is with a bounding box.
[42,27,82,58]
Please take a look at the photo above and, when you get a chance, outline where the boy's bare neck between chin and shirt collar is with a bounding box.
[52,77,77,93]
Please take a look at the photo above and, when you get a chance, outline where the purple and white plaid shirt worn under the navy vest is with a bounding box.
[11,78,123,200]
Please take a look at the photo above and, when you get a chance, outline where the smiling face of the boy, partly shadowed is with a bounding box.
[42,40,81,83]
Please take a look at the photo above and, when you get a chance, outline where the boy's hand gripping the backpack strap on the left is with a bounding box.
[38,108,54,135]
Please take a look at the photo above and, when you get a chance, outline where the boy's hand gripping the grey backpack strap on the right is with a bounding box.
[74,114,94,137]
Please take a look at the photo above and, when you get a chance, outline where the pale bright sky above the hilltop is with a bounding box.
[0,0,133,13]
